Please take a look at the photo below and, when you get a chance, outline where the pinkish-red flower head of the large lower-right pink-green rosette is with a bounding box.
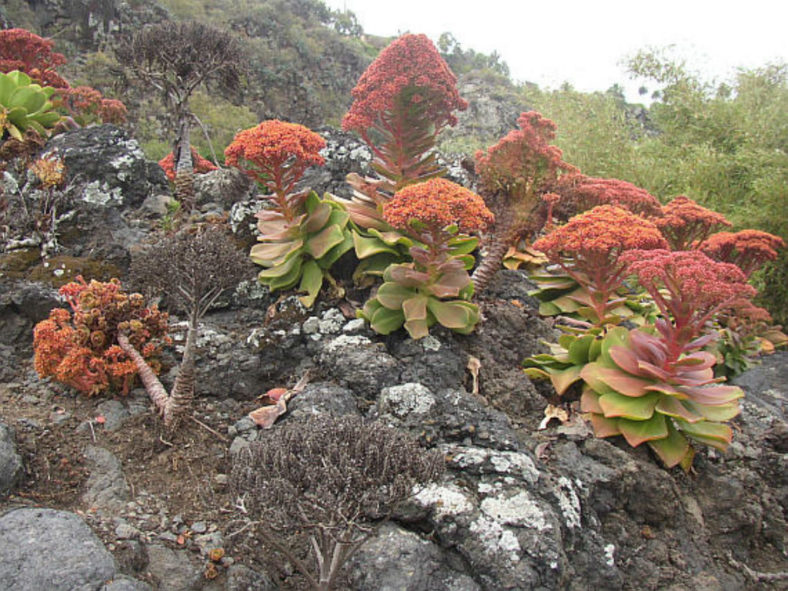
[621,250,755,358]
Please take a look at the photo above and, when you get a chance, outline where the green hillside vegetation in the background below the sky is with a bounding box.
[0,0,788,324]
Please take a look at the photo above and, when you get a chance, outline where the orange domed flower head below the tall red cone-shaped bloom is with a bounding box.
[383,178,495,234]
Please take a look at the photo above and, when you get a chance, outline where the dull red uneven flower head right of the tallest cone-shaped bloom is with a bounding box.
[476,111,576,198]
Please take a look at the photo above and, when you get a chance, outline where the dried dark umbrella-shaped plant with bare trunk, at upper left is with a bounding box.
[116,22,242,211]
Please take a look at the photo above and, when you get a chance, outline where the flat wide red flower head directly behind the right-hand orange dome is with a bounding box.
[555,174,662,219]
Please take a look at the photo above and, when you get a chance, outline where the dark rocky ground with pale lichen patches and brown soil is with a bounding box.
[0,127,788,591]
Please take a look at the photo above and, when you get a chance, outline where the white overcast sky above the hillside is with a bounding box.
[325,0,788,98]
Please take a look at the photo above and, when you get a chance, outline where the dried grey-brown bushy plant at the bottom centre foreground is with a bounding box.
[230,416,443,591]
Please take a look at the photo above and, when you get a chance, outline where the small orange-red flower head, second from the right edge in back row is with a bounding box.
[655,195,731,250]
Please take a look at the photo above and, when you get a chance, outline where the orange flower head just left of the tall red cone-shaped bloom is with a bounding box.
[224,119,326,195]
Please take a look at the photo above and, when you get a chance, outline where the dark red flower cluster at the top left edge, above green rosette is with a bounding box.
[0,29,68,88]
